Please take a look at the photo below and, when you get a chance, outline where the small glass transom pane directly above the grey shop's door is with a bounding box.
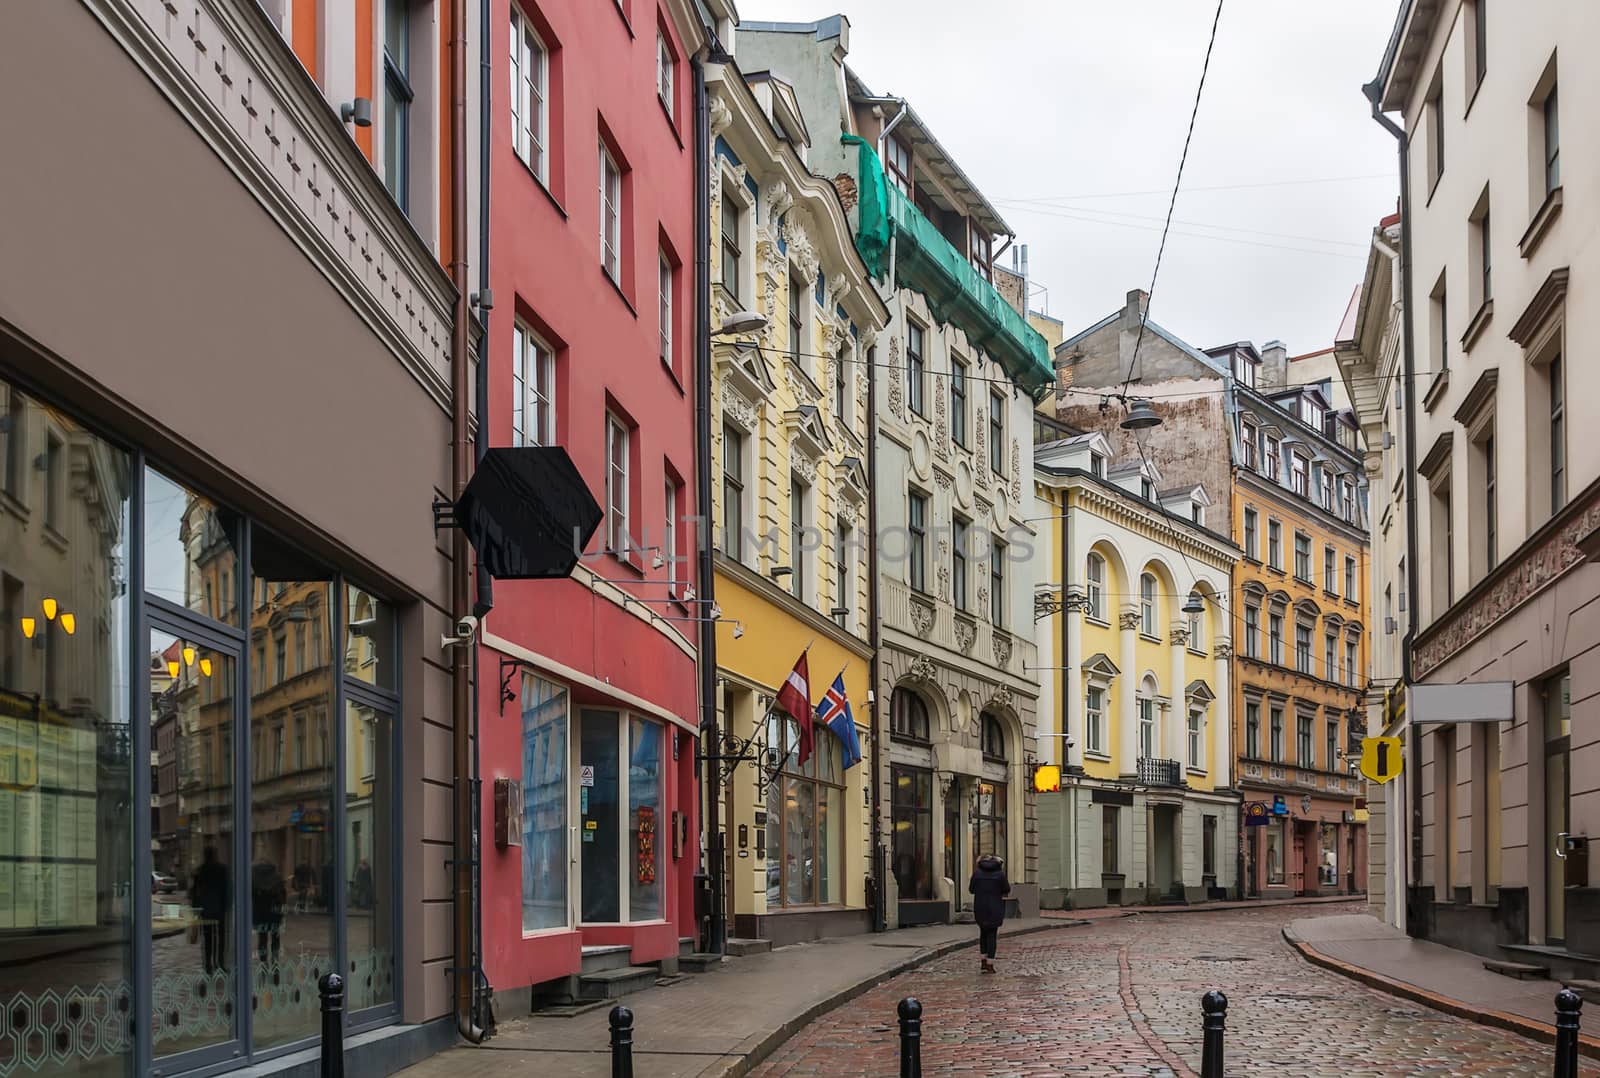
[144,467,240,625]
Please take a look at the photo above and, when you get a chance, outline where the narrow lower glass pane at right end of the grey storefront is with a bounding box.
[342,701,395,1011]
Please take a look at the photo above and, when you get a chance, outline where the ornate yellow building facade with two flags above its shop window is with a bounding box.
[707,67,888,945]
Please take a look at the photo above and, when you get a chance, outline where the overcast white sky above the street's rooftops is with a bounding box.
[739,0,1398,353]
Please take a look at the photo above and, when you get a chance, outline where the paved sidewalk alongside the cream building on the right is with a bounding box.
[1283,913,1600,1057]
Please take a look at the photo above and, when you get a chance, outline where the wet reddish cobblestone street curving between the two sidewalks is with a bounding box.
[752,907,1600,1078]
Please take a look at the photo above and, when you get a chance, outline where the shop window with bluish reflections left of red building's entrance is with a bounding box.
[522,673,569,932]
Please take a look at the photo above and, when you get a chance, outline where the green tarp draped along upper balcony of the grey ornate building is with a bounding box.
[845,134,1056,398]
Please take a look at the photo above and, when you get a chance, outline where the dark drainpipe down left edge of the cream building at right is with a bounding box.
[1362,78,1422,931]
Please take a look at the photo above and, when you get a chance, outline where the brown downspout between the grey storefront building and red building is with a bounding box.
[450,0,483,1044]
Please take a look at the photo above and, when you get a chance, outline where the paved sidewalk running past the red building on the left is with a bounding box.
[388,918,1082,1078]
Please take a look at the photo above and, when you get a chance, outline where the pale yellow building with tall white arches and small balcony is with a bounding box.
[1034,419,1238,908]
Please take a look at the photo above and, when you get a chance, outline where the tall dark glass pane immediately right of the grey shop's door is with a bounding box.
[250,528,338,1049]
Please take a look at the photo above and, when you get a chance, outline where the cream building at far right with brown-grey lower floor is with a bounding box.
[1370,0,1600,959]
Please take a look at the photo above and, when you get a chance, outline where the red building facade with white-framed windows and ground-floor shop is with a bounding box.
[478,0,704,1011]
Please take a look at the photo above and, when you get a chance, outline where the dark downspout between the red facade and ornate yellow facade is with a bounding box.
[693,38,726,955]
